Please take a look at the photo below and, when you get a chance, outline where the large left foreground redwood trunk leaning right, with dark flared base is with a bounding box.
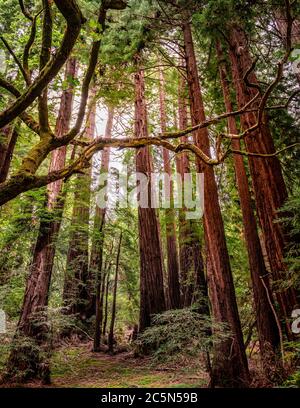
[7,58,76,381]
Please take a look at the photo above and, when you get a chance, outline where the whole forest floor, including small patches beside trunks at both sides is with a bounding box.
[0,342,300,388]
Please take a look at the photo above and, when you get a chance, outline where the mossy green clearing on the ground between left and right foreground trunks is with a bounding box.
[51,343,208,388]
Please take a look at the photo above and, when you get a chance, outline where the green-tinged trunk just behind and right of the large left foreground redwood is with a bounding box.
[63,90,96,322]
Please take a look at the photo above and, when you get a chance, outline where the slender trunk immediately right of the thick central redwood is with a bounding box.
[159,67,180,309]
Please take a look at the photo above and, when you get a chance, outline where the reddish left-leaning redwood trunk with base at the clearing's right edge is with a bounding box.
[183,23,249,387]
